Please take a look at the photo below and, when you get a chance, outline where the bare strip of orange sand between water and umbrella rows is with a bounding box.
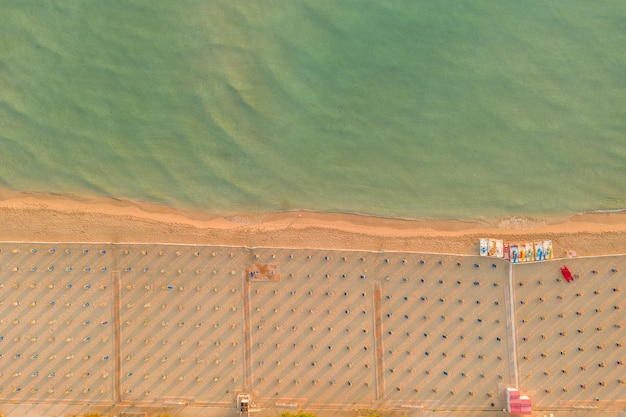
[0,191,626,257]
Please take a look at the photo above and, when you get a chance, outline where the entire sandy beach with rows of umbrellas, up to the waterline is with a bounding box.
[0,190,626,417]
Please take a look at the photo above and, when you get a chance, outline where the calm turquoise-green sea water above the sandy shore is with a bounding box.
[0,0,626,219]
